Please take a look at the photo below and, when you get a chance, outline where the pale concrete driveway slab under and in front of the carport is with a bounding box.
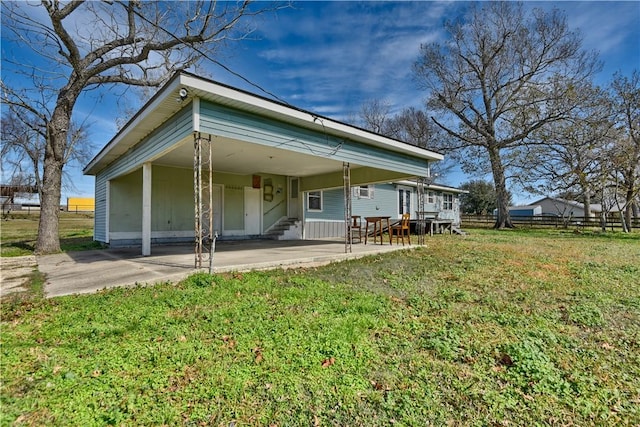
[37,240,409,297]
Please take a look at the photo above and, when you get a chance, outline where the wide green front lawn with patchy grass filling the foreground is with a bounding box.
[0,230,640,426]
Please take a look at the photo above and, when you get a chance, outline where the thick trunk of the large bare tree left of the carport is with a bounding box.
[35,104,71,254]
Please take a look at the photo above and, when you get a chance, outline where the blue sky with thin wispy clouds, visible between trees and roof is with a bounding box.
[3,1,640,203]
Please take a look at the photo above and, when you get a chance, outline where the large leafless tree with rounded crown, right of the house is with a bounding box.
[414,2,599,228]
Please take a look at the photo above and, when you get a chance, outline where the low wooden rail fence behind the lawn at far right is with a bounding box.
[461,214,640,231]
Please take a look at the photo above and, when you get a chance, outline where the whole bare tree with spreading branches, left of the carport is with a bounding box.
[1,0,282,253]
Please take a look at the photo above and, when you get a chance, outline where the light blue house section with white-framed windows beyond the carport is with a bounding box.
[304,180,466,239]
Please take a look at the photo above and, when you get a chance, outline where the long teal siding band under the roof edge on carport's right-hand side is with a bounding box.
[200,101,428,176]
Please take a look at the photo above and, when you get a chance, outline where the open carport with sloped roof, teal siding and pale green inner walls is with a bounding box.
[84,72,443,255]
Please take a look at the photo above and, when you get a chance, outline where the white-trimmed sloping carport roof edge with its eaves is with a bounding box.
[84,71,443,175]
